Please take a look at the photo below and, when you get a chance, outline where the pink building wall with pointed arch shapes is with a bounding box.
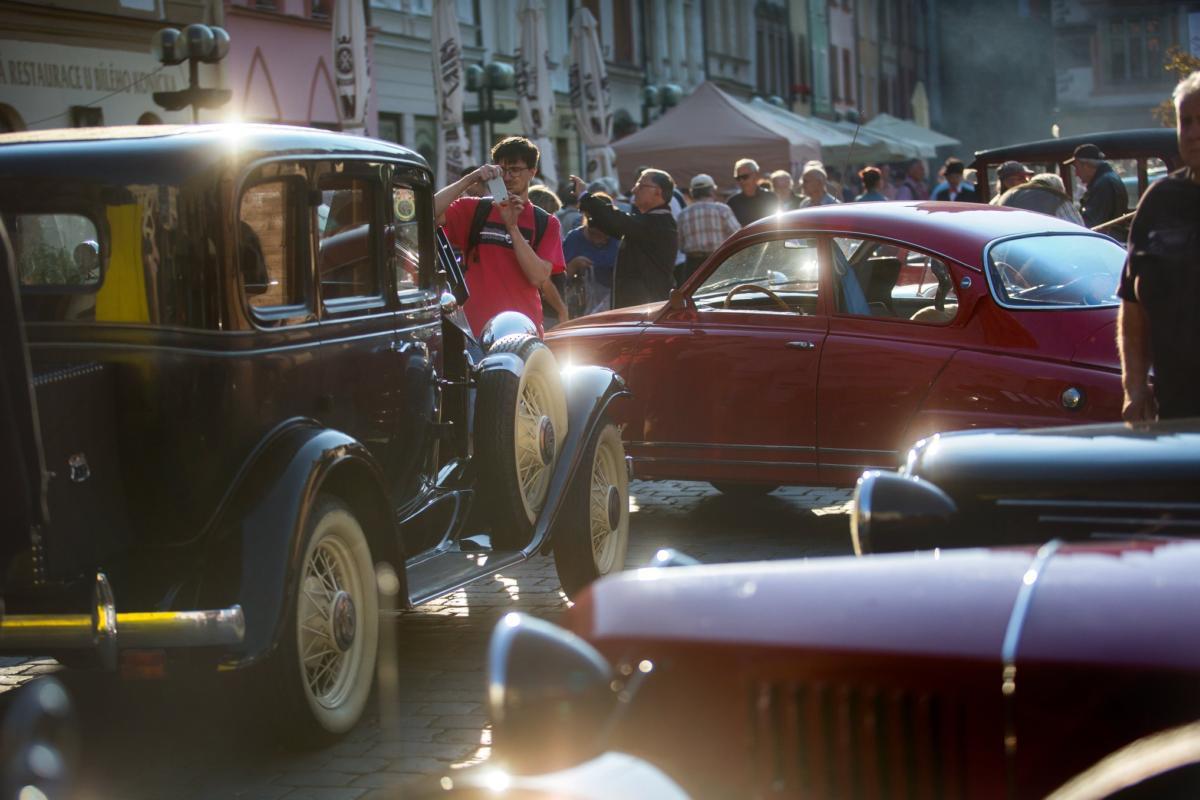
[224,0,378,136]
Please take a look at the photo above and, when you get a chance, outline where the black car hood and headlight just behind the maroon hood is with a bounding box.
[851,420,1200,555]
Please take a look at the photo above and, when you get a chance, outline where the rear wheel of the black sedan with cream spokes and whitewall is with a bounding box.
[255,494,379,747]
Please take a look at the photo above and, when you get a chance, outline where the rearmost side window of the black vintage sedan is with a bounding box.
[238,178,310,323]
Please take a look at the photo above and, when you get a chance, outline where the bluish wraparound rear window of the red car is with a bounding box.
[988,234,1124,308]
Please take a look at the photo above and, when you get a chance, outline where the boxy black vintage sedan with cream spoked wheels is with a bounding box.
[0,126,629,740]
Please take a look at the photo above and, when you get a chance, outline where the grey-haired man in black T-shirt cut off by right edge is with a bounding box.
[1117,72,1200,422]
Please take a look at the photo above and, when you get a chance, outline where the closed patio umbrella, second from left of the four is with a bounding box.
[433,0,467,187]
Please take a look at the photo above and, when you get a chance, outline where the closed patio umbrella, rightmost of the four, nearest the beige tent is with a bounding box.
[570,6,617,181]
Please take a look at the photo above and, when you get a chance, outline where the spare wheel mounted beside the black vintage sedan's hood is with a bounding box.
[475,335,566,549]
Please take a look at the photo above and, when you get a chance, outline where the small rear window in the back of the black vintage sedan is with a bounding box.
[6,213,101,288]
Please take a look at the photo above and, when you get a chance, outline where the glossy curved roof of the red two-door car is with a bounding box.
[737,200,1106,267]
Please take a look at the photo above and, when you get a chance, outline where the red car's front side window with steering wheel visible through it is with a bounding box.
[692,239,821,314]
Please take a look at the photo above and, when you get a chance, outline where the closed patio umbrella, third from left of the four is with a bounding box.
[515,0,558,186]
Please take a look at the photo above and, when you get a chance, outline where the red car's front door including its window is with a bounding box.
[625,234,827,483]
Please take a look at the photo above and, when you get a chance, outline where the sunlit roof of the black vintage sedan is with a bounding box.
[0,122,430,169]
